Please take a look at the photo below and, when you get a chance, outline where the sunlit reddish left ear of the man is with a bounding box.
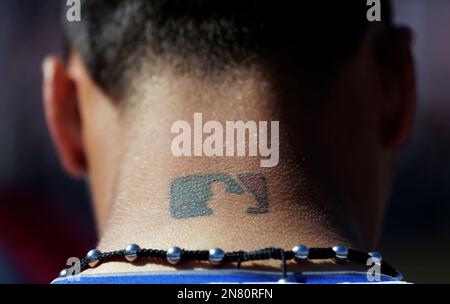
[43,57,87,178]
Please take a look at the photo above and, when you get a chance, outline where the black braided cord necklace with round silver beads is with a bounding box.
[59,244,402,281]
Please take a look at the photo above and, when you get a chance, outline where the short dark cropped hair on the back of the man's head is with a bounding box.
[65,0,391,96]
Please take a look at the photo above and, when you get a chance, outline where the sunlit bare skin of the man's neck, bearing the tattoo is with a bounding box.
[82,69,374,273]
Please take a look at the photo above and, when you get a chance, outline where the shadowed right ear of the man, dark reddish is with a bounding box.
[378,27,417,149]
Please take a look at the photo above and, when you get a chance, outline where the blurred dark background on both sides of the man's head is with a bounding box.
[0,0,450,283]
